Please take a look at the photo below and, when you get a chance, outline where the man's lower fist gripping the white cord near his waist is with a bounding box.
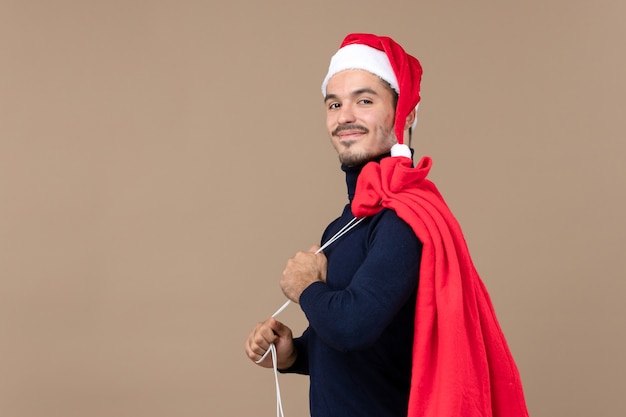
[245,317,297,369]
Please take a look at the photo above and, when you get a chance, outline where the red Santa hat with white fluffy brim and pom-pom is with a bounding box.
[322,33,422,158]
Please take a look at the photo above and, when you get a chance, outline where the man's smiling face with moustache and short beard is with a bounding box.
[324,70,396,166]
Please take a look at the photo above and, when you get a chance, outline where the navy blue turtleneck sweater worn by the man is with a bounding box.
[283,161,422,417]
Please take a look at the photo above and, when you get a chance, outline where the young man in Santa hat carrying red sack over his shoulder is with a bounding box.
[245,34,528,417]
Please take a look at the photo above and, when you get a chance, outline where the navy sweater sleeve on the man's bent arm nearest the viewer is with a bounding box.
[299,211,422,351]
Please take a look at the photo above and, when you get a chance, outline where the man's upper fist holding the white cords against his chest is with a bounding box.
[280,245,328,303]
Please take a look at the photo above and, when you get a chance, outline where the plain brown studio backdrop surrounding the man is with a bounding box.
[0,0,626,417]
